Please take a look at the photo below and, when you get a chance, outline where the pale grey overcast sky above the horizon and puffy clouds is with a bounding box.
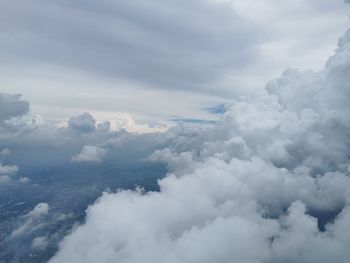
[0,0,349,122]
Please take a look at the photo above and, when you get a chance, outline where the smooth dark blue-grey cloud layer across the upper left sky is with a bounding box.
[0,0,259,90]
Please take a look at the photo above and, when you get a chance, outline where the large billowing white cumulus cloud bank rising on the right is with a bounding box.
[50,27,350,263]
